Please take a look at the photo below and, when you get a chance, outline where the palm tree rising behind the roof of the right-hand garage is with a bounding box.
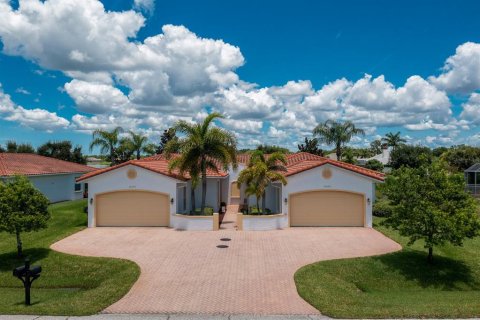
[313,120,365,160]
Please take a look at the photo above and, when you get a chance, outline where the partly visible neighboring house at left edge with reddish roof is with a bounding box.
[0,153,96,202]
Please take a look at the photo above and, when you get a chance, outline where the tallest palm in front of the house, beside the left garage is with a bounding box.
[164,112,237,214]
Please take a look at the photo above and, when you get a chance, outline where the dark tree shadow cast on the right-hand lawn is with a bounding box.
[375,249,480,291]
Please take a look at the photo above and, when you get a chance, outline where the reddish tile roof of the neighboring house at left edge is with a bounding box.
[0,153,96,177]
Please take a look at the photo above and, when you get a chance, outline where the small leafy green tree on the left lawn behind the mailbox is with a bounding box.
[0,176,50,257]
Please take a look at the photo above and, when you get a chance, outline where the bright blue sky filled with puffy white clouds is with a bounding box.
[0,0,480,149]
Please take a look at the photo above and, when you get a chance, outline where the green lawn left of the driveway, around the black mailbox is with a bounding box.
[0,200,140,315]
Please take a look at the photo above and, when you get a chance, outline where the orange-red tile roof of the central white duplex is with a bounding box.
[77,152,384,181]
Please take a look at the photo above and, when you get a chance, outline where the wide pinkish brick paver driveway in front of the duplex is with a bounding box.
[52,228,400,314]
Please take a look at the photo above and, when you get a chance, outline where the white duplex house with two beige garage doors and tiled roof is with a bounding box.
[77,153,384,228]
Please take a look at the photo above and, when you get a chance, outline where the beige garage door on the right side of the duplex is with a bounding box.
[289,191,365,227]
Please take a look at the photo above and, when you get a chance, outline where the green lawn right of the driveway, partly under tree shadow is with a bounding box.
[295,218,480,318]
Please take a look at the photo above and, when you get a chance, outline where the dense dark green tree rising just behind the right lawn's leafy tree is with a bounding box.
[390,144,432,169]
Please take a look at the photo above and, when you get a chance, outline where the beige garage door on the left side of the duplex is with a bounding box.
[96,191,170,227]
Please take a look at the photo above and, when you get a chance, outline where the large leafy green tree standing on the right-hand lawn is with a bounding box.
[383,161,480,262]
